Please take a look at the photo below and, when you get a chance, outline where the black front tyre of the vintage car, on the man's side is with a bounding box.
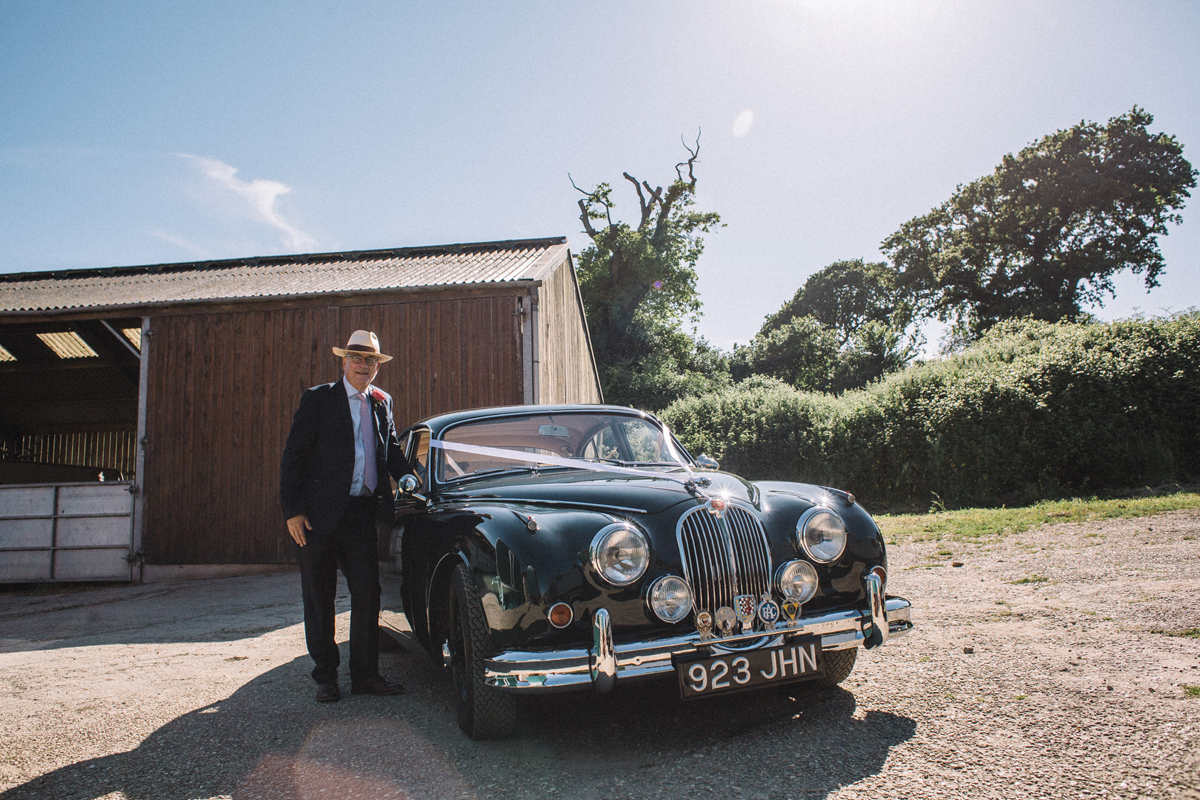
[449,565,517,739]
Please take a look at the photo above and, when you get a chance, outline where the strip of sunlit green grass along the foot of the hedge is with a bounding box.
[875,492,1200,542]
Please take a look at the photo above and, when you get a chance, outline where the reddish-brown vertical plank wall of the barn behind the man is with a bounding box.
[143,297,520,564]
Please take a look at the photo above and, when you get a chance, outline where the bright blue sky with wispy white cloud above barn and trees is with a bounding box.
[0,0,1200,349]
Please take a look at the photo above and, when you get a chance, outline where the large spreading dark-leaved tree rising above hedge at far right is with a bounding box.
[883,107,1196,339]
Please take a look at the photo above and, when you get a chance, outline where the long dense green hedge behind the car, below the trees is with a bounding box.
[662,313,1200,507]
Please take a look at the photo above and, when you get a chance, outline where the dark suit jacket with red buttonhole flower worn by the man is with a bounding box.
[280,379,413,536]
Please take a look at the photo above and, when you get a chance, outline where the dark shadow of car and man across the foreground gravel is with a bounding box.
[0,645,916,800]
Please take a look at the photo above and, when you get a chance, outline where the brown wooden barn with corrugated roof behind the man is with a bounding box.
[0,237,602,582]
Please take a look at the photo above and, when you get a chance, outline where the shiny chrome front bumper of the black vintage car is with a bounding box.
[484,591,913,692]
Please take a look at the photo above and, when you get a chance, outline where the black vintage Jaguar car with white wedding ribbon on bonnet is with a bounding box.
[391,405,912,739]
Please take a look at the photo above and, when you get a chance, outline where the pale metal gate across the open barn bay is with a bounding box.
[0,481,133,583]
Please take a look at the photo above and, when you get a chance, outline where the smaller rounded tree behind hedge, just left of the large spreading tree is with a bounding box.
[761,258,913,347]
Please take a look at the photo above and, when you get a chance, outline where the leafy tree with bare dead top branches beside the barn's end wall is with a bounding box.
[571,137,727,409]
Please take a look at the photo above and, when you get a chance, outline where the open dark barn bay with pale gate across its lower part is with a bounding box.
[0,318,143,583]
